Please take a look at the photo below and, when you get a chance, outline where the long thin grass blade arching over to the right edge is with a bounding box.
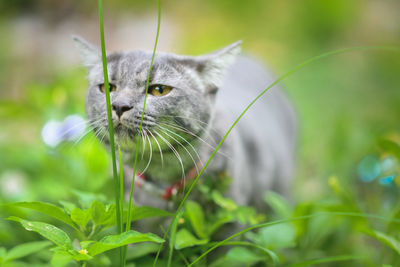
[153,46,400,267]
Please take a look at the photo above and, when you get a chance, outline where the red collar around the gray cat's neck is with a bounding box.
[135,162,202,200]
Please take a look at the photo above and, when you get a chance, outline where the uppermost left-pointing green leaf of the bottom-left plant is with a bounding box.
[8,201,76,229]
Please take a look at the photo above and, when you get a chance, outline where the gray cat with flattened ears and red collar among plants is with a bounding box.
[74,37,296,211]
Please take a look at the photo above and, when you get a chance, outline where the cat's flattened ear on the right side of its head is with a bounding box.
[181,41,242,94]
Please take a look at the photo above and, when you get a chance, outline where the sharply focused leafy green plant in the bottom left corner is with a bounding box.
[7,200,170,266]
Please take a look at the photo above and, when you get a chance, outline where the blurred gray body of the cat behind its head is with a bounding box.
[214,57,296,207]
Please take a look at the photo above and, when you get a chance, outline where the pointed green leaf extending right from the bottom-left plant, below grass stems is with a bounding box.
[87,230,164,256]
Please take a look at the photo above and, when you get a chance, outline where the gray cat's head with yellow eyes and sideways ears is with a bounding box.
[74,37,241,149]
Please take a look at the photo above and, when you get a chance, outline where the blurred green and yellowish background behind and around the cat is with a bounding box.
[0,0,400,266]
